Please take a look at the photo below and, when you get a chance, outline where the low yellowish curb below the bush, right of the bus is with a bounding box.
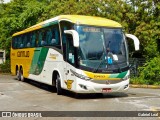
[129,84,160,89]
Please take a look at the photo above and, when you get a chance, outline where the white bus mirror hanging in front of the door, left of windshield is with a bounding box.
[64,30,79,47]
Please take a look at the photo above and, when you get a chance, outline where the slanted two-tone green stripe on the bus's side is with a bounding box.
[30,48,48,75]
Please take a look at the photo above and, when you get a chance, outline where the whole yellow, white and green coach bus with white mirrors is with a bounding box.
[11,15,139,95]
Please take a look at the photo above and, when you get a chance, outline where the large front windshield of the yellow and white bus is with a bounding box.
[76,25,128,71]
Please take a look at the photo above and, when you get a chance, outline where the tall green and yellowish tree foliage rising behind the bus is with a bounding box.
[0,0,160,58]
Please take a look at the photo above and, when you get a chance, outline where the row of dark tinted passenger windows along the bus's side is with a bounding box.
[12,24,61,49]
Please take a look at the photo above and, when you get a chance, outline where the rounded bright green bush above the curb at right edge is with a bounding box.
[139,56,160,85]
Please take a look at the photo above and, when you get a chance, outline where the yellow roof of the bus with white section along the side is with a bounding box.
[13,15,122,36]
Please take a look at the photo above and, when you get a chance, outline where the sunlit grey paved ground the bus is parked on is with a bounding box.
[0,75,160,120]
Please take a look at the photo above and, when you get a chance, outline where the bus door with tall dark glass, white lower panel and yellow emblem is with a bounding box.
[60,21,75,89]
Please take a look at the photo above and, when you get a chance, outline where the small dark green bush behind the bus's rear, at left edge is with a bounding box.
[0,60,11,73]
